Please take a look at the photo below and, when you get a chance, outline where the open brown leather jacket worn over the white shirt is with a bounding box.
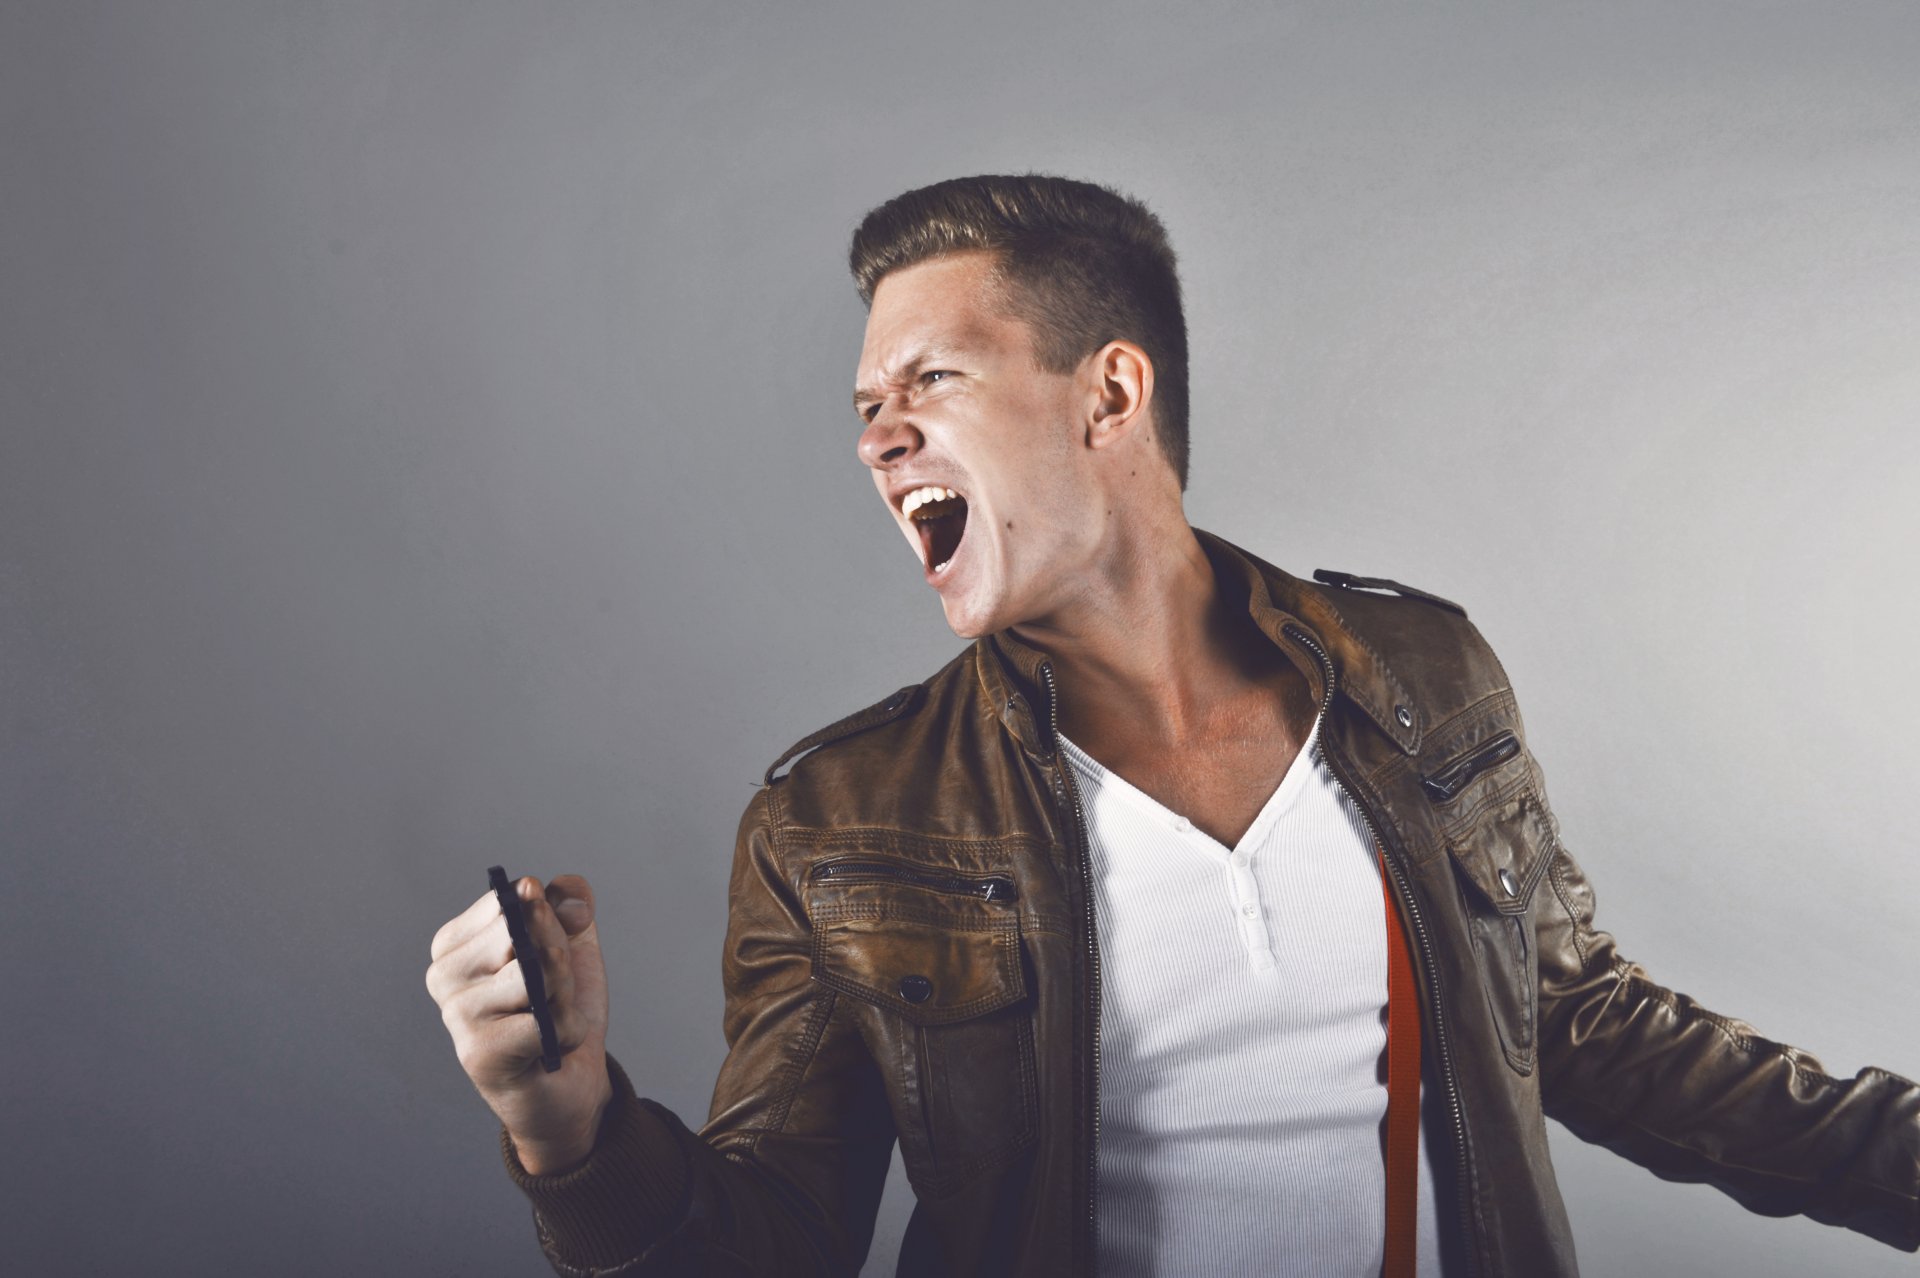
[503,533,1920,1278]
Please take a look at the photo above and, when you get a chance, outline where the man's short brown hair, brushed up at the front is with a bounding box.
[847,173,1187,489]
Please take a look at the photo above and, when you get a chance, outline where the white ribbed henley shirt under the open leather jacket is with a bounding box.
[1062,723,1440,1278]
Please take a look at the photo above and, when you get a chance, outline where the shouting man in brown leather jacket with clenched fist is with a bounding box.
[428,177,1920,1276]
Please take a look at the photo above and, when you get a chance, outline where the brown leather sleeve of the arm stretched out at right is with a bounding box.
[1536,832,1920,1251]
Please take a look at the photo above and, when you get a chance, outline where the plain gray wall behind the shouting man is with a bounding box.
[0,0,1920,1276]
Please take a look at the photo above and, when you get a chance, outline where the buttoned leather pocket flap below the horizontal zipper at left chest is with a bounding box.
[814,911,1027,1025]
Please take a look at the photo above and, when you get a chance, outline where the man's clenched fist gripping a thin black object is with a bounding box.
[426,875,612,1174]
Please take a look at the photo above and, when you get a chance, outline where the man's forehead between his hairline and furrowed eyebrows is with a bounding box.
[858,253,1027,386]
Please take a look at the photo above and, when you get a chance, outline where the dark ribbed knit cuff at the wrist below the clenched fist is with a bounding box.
[499,1055,689,1268]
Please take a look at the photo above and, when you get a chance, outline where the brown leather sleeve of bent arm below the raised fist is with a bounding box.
[501,787,895,1278]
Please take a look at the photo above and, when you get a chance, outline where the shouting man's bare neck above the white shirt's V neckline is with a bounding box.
[1014,510,1284,748]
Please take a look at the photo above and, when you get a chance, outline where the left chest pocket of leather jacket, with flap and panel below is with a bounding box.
[810,855,1039,1197]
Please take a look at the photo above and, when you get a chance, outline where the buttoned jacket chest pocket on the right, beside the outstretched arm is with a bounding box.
[1423,733,1553,1075]
